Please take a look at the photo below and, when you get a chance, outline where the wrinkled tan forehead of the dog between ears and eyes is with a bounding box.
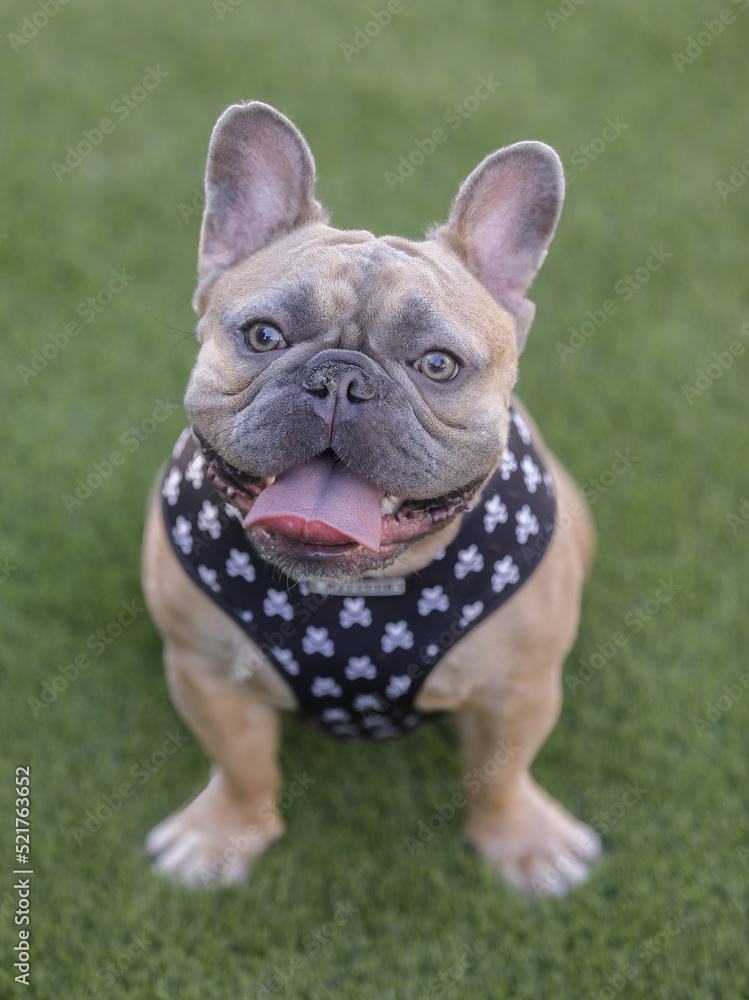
[214,226,511,346]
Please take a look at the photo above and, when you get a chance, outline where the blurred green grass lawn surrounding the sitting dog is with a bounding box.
[0,0,749,1000]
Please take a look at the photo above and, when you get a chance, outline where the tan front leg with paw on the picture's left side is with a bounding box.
[146,640,284,885]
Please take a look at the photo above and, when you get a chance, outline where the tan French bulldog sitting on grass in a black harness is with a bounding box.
[143,102,600,896]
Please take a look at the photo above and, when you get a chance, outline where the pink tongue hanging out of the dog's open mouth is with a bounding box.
[242,456,384,552]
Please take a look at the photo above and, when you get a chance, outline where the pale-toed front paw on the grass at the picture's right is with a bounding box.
[464,778,601,897]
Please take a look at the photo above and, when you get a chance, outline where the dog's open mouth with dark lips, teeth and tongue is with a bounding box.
[204,448,476,566]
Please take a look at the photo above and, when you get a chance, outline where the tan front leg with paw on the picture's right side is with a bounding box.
[459,665,600,896]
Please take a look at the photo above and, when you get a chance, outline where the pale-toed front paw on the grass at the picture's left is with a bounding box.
[145,775,284,888]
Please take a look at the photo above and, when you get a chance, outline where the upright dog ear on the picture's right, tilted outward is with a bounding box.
[433,142,564,353]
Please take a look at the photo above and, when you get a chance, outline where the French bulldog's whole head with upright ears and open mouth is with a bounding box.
[185,103,563,579]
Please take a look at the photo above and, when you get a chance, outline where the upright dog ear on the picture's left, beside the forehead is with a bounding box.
[193,101,327,315]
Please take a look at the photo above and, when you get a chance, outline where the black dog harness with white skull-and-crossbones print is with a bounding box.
[162,410,556,740]
